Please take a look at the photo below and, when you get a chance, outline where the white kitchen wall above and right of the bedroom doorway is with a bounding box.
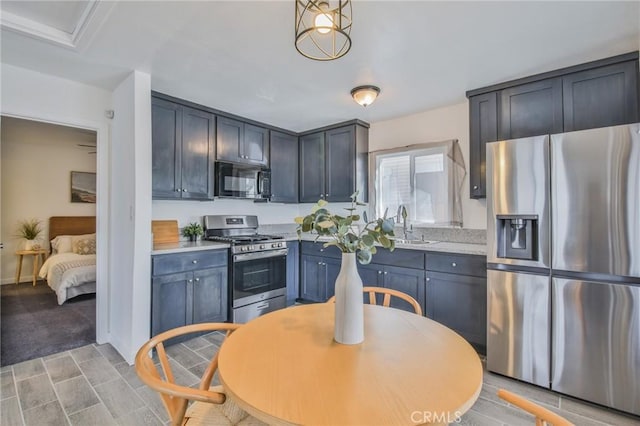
[0,63,111,343]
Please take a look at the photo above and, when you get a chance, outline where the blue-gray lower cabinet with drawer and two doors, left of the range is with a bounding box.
[151,250,228,342]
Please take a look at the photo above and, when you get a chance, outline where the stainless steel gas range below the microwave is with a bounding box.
[204,215,288,323]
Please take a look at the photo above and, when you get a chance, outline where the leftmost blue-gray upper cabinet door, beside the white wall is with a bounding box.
[151,98,182,198]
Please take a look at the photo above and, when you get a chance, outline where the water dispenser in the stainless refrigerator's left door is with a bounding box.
[496,215,538,260]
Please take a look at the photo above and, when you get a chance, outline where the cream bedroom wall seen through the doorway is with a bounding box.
[0,118,96,284]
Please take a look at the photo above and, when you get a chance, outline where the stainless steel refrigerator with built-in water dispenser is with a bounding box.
[487,123,640,415]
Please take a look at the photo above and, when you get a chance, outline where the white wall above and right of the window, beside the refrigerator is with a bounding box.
[369,102,487,229]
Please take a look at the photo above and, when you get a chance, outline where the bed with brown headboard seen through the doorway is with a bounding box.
[38,216,96,305]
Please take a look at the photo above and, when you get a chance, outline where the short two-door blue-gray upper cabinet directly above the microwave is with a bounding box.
[217,116,269,166]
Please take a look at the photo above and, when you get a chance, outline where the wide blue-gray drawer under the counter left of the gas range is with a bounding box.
[151,250,227,276]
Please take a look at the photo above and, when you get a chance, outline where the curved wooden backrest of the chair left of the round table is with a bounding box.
[135,323,240,425]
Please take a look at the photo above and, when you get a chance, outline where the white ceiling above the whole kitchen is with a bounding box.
[0,0,640,130]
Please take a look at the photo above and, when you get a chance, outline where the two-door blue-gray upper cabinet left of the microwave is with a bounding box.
[151,97,215,200]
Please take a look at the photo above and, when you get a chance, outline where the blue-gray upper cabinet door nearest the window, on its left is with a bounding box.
[324,126,356,201]
